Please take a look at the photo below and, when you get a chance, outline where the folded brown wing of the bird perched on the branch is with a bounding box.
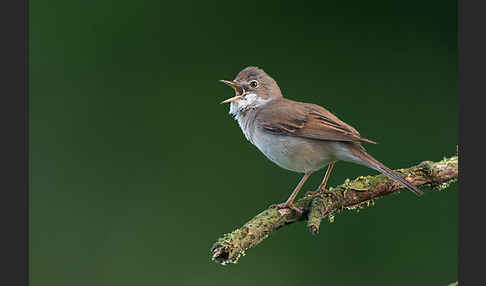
[256,98,376,144]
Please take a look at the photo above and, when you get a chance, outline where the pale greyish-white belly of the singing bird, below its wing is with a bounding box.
[251,128,340,173]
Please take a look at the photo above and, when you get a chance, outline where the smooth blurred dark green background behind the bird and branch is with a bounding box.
[30,0,458,286]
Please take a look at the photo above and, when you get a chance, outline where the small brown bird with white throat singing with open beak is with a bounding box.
[221,67,423,213]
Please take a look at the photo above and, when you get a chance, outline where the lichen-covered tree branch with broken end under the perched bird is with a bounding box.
[211,156,459,265]
